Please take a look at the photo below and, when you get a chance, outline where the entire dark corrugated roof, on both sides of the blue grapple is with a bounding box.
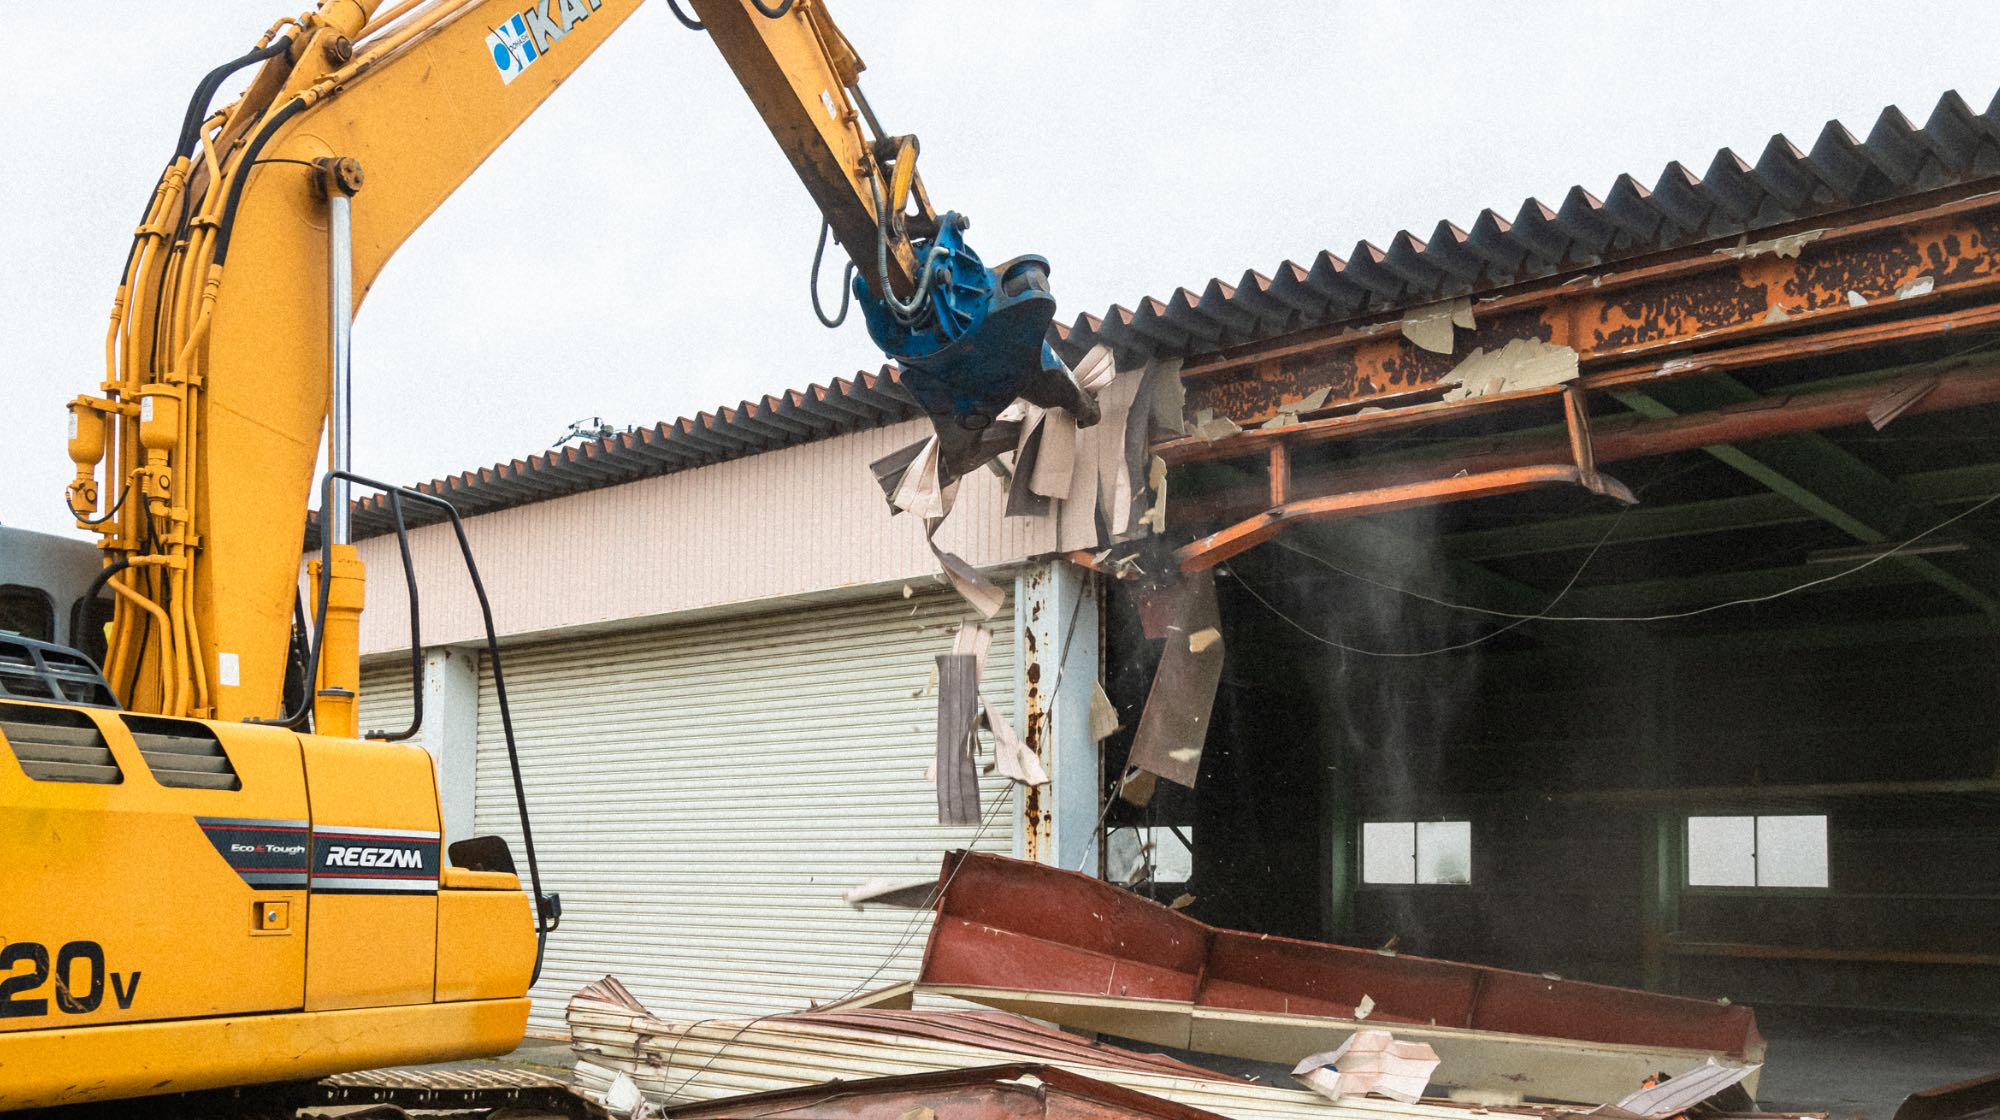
[344,92,2000,544]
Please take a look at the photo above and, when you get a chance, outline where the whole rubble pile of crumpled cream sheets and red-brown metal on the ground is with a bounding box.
[568,852,1800,1120]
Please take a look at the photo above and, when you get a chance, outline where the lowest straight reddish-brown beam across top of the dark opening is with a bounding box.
[1168,364,2000,532]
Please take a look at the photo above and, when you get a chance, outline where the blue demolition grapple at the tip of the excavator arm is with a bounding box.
[854,214,1098,474]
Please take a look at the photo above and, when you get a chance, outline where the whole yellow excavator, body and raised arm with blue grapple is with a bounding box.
[0,0,1094,1110]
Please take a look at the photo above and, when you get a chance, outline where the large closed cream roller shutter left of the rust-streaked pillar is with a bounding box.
[474,590,1018,1030]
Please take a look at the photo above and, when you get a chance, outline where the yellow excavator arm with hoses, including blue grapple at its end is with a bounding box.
[70,0,1094,736]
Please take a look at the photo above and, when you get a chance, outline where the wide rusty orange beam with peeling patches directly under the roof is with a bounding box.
[1182,194,2000,428]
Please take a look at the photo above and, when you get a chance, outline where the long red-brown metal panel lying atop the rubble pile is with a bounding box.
[918,852,1762,1058]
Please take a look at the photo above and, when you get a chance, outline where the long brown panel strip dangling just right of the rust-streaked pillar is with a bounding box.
[1130,572,1224,790]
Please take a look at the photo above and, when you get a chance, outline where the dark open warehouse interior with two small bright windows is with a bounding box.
[1106,346,2000,1014]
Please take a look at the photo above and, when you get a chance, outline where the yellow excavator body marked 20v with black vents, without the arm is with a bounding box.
[0,700,534,1110]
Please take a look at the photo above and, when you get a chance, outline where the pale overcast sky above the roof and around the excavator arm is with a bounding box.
[0,0,2000,532]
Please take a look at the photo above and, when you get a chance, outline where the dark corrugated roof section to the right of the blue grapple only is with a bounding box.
[1058,92,2000,368]
